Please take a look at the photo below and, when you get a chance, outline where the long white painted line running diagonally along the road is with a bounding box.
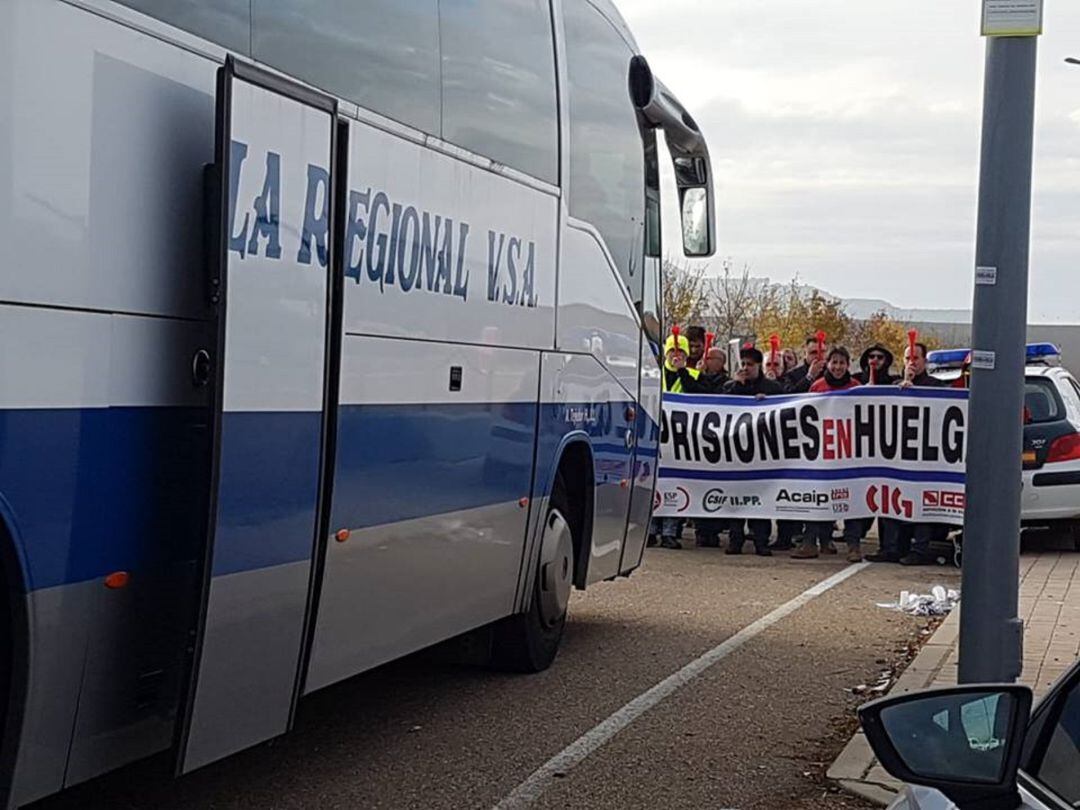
[495,563,869,810]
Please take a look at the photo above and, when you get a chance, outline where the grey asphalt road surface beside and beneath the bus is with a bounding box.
[37,540,959,810]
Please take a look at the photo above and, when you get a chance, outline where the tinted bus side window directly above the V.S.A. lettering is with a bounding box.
[438,0,558,184]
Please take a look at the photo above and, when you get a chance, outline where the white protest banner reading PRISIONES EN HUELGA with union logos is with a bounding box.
[653,386,972,524]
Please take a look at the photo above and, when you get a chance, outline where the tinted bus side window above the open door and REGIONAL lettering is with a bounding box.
[245,0,441,135]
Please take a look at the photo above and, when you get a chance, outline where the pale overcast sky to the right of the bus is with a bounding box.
[618,0,1080,323]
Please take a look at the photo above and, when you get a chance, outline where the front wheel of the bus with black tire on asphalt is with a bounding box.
[491,475,575,673]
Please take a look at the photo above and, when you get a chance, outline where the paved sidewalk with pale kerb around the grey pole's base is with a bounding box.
[827,551,1080,805]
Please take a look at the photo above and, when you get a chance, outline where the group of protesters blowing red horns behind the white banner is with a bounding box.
[649,326,948,565]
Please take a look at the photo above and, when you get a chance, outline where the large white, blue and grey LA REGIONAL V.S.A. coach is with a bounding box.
[0,0,715,806]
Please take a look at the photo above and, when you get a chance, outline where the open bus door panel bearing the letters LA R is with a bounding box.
[178,59,337,772]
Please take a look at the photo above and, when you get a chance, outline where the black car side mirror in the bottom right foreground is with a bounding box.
[859,684,1031,810]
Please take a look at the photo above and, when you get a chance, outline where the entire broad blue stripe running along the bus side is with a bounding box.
[0,403,639,590]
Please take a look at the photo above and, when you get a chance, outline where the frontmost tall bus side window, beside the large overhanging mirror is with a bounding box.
[564,2,645,301]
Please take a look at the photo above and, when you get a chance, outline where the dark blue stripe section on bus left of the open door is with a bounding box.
[0,407,206,590]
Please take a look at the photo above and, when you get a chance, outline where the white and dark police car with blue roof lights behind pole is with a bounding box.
[927,343,1080,535]
